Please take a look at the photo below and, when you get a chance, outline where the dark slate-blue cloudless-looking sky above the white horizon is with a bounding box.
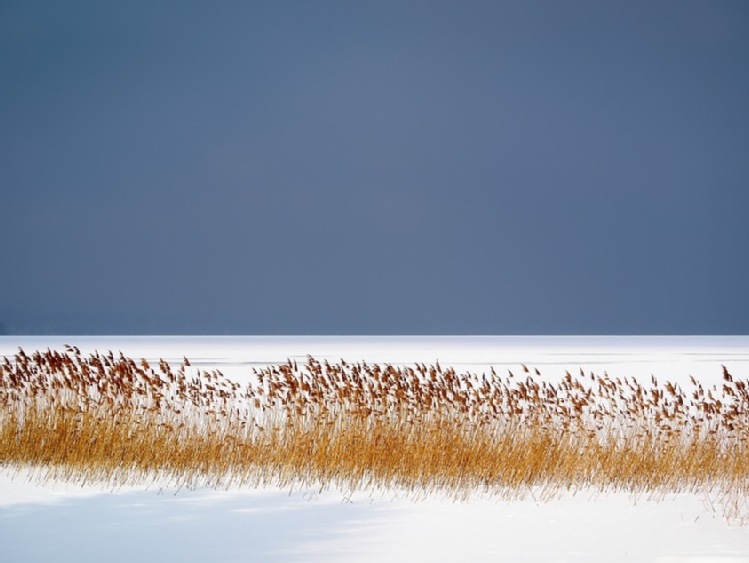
[0,0,749,334]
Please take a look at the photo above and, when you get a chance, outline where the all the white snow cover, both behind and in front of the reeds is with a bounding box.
[0,336,749,563]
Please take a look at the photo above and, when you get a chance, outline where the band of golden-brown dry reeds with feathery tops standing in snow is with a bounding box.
[0,347,749,512]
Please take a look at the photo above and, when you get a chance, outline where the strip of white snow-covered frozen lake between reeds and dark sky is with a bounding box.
[0,336,749,379]
